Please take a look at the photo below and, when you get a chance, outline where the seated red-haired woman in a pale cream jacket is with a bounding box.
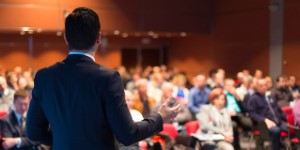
[198,88,234,150]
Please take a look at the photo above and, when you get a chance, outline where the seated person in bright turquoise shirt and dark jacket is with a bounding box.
[224,79,252,150]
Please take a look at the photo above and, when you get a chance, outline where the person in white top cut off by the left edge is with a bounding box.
[0,76,14,113]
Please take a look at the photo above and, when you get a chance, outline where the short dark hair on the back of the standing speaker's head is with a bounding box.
[65,7,100,50]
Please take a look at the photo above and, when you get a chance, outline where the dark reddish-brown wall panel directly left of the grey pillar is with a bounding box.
[213,0,269,77]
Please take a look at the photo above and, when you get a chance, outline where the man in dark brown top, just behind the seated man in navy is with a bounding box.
[271,75,293,107]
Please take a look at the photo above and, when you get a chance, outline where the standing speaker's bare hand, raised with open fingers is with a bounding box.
[158,100,181,122]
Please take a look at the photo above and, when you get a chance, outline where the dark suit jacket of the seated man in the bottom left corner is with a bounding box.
[0,112,37,150]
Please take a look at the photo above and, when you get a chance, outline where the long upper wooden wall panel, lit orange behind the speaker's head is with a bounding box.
[0,0,210,33]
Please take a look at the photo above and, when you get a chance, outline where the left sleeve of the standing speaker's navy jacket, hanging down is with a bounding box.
[26,73,52,145]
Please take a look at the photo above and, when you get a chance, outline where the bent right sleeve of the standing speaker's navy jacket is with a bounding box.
[104,72,163,145]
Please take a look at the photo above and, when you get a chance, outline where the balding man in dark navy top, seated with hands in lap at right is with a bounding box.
[248,78,288,150]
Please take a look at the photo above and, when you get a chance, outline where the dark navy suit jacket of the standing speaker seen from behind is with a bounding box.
[26,54,163,150]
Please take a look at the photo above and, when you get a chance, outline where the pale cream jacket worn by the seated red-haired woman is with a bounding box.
[198,104,233,135]
